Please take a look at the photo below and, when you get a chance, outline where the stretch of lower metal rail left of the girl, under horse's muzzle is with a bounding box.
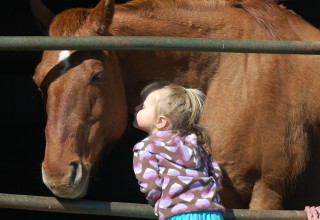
[0,193,157,219]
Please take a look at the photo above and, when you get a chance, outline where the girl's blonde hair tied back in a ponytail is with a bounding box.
[141,82,211,153]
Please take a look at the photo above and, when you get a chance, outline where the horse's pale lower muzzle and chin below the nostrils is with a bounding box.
[42,163,91,199]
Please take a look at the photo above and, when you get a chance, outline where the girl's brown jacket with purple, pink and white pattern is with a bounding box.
[133,130,225,220]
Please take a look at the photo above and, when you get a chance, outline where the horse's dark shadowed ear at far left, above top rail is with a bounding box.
[30,0,55,34]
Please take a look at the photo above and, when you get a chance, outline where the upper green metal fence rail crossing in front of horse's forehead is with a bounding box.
[0,36,320,55]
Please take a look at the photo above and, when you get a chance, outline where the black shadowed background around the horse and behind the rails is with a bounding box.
[0,0,320,220]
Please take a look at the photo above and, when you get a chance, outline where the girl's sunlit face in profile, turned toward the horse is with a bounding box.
[133,90,160,133]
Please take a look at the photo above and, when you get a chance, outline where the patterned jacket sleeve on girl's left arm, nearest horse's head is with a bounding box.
[133,150,162,206]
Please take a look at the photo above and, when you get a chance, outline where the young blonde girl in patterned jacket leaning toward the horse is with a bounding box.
[133,83,225,220]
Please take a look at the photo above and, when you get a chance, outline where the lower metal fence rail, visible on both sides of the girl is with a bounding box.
[0,193,308,220]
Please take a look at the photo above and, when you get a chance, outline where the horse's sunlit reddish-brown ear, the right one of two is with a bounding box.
[89,0,115,35]
